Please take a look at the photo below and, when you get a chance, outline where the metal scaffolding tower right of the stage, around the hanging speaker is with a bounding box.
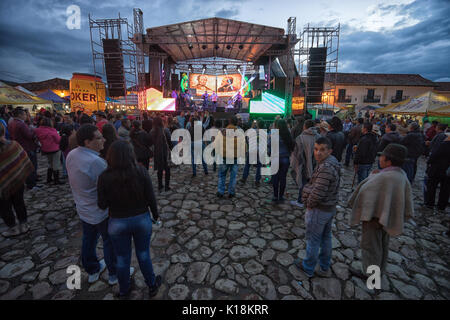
[295,24,340,111]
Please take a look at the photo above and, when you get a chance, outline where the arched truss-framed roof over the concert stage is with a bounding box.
[141,18,298,62]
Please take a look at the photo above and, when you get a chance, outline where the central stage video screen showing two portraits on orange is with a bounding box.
[189,73,242,97]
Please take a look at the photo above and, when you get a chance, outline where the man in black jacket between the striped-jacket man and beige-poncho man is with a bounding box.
[353,122,378,183]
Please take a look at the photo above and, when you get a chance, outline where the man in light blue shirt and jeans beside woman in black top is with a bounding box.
[66,124,117,285]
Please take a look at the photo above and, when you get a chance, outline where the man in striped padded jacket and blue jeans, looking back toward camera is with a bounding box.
[294,137,341,278]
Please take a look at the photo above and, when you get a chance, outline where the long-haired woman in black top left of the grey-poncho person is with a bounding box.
[269,120,294,202]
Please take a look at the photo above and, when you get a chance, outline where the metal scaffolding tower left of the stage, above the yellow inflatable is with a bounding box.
[89,11,137,103]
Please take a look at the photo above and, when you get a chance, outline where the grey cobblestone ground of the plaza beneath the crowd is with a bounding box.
[0,157,450,300]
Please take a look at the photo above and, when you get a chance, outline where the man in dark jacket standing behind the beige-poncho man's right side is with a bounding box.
[400,122,425,184]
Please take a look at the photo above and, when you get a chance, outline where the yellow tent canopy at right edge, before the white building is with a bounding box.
[375,91,450,117]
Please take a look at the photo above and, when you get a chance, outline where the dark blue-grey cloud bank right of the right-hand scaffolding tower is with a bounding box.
[340,0,450,80]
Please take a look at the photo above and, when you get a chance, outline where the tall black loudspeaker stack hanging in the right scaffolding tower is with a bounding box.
[306,47,327,103]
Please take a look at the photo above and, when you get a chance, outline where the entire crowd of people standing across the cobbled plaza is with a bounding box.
[0,108,450,297]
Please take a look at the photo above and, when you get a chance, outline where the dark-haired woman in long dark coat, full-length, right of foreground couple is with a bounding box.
[150,116,170,192]
